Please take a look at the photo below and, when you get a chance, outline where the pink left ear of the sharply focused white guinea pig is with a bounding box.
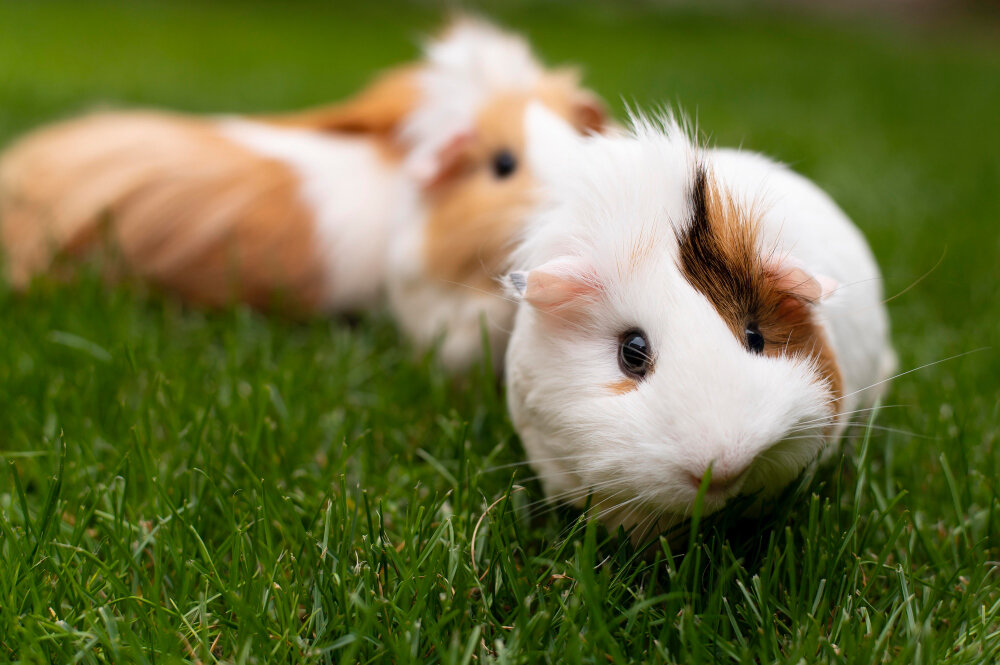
[504,256,601,321]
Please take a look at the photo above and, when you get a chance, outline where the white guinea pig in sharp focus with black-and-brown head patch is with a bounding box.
[505,107,895,539]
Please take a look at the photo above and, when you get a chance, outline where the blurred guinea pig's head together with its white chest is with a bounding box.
[387,23,608,370]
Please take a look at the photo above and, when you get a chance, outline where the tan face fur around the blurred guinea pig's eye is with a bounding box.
[424,78,603,293]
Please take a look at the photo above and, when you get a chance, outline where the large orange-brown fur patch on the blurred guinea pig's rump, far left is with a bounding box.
[0,112,324,309]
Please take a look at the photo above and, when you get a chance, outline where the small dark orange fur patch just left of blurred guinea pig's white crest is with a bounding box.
[264,65,420,137]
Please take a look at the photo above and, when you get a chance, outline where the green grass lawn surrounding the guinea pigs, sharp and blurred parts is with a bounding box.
[0,2,1000,664]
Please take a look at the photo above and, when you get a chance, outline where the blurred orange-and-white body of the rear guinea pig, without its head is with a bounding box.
[0,111,415,310]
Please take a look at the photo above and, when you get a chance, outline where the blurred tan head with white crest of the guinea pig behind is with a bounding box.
[400,18,606,291]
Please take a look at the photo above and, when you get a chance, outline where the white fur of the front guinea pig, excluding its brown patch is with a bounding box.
[506,108,893,528]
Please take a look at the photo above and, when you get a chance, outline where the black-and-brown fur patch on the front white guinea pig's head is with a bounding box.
[679,167,842,404]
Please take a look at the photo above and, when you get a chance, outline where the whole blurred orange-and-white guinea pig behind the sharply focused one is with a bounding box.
[0,19,604,338]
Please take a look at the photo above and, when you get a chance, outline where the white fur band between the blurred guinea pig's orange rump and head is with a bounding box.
[218,118,418,310]
